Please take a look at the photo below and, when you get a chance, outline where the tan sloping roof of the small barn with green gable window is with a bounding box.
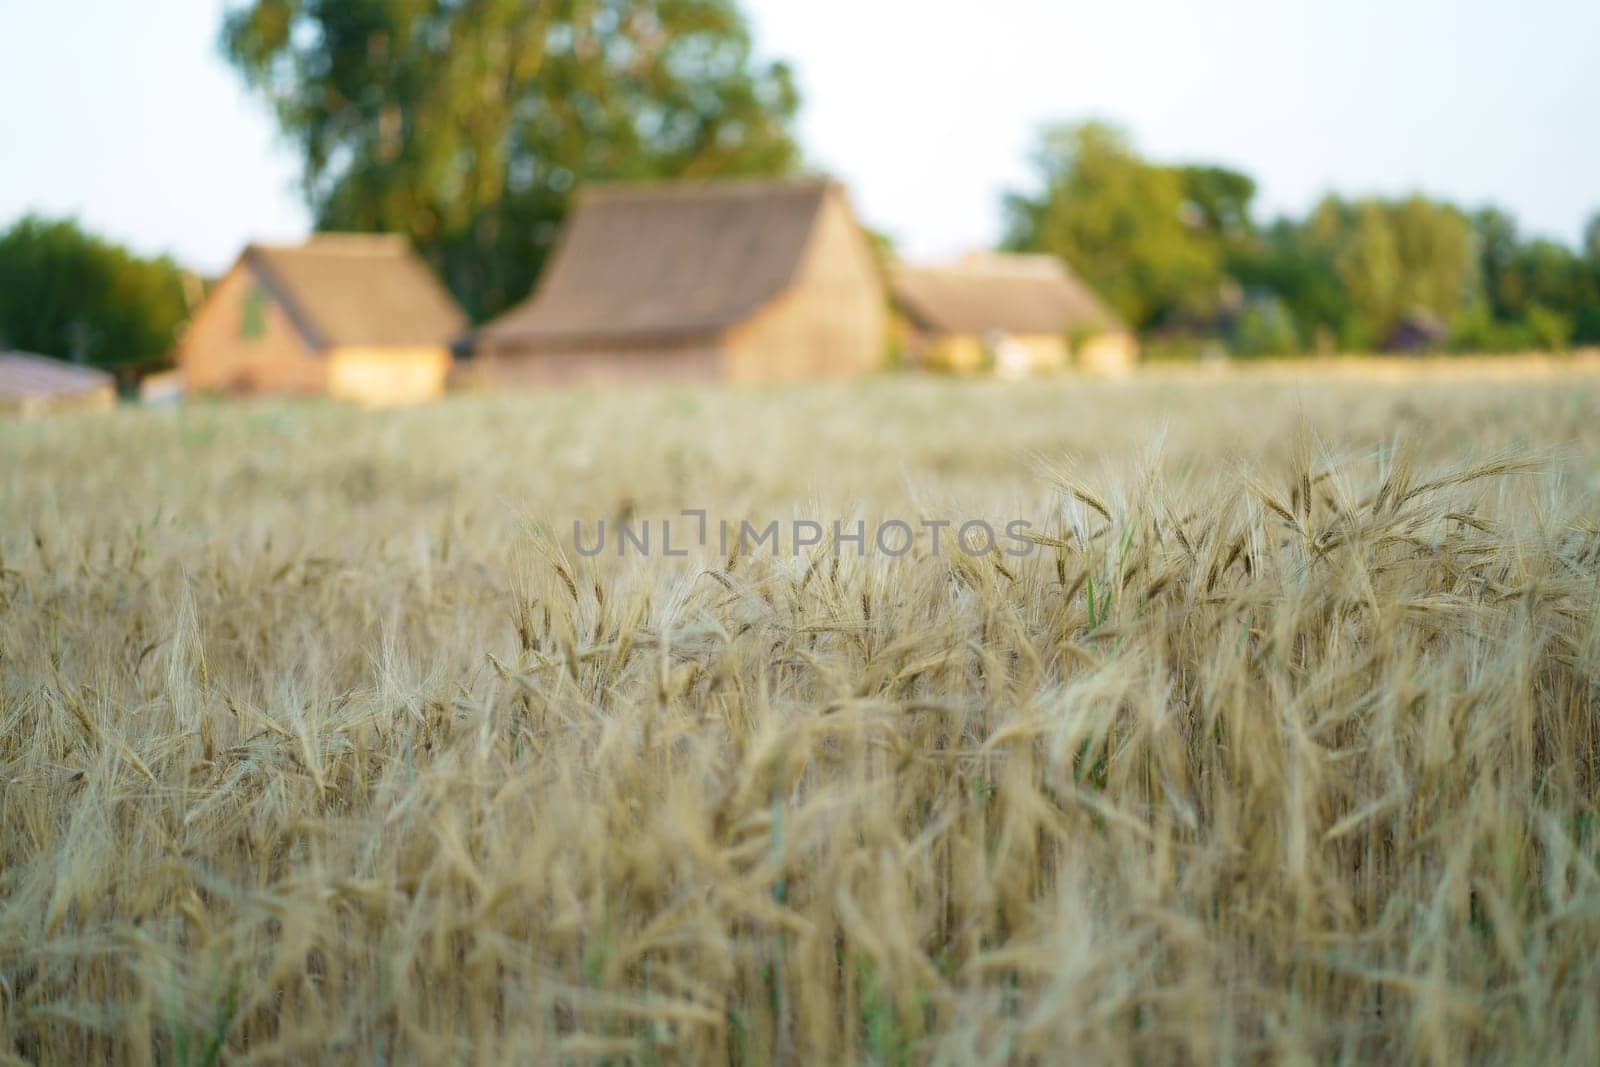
[245,234,467,347]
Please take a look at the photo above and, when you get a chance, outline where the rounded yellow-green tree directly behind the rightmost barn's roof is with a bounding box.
[1005,123,1222,330]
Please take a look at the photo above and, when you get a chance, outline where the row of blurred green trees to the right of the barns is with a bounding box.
[1005,122,1600,355]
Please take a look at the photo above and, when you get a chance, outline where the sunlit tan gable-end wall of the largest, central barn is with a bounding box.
[725,190,890,381]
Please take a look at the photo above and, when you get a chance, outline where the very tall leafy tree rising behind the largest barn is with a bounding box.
[222,0,798,318]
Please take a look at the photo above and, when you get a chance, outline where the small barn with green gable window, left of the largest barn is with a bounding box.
[178,234,467,405]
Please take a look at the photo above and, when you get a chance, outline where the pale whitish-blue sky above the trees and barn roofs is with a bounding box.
[0,0,1600,270]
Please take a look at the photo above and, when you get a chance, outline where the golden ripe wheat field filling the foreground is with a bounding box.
[0,364,1600,1064]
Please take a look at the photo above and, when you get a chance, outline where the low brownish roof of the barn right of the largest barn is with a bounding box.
[890,254,1126,334]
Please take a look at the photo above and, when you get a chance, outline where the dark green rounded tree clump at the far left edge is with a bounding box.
[0,214,187,386]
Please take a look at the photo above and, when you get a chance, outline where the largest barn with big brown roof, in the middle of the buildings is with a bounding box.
[474,179,888,384]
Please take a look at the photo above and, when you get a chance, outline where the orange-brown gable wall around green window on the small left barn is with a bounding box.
[178,262,328,394]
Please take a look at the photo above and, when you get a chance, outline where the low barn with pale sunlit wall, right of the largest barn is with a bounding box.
[891,253,1139,378]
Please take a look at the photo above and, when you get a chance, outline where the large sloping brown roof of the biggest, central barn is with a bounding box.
[483,179,832,342]
